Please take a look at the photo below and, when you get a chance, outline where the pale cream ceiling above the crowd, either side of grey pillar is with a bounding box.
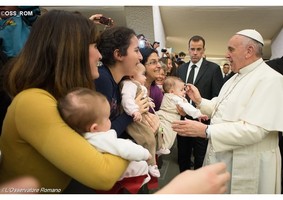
[44,6,283,59]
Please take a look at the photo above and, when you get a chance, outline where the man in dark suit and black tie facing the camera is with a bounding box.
[177,35,223,172]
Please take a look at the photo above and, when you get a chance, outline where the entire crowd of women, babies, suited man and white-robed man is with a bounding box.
[0,6,283,194]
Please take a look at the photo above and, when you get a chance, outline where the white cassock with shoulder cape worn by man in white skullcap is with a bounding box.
[200,59,283,194]
